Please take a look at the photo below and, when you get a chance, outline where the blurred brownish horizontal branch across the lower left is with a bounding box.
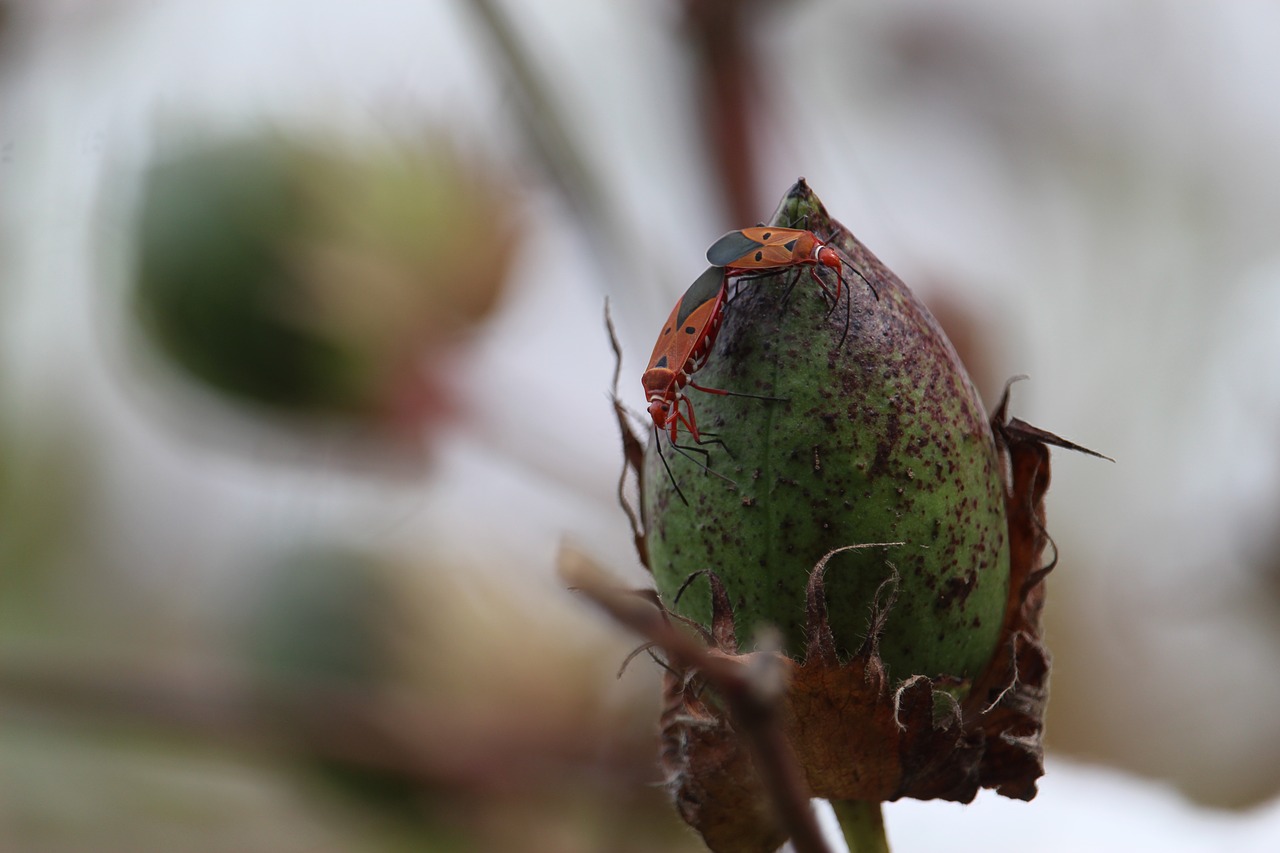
[0,660,652,792]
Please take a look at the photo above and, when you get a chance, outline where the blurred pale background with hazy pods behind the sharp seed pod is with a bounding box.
[0,0,1280,852]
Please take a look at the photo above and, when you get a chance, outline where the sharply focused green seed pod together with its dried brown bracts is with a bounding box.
[611,181,1100,853]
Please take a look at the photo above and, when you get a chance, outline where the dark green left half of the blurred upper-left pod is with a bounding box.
[136,138,358,409]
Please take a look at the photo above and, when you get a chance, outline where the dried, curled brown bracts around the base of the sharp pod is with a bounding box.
[659,388,1100,850]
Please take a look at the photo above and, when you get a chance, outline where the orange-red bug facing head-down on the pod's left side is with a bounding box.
[640,266,728,444]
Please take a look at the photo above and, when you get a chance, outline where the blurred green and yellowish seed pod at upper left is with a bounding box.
[132,133,517,429]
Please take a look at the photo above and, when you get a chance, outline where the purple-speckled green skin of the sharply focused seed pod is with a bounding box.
[644,182,1009,678]
